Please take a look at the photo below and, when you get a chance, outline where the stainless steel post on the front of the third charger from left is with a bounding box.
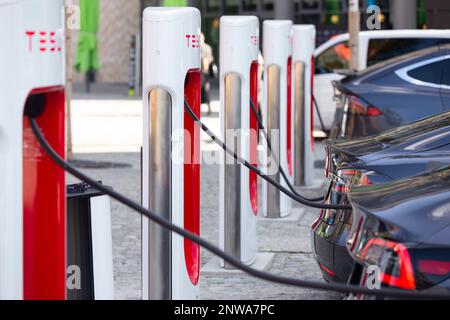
[224,74,242,269]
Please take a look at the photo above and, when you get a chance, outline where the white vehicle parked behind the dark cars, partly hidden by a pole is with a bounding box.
[314,30,450,130]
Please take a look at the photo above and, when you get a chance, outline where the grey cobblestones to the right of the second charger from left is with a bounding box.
[200,148,339,300]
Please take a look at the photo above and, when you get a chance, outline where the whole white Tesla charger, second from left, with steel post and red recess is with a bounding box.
[142,7,201,300]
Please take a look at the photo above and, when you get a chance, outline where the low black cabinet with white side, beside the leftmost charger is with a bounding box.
[66,183,114,300]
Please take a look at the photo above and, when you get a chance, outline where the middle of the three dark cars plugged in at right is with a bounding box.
[312,112,450,282]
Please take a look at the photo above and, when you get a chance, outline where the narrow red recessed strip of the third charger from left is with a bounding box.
[249,61,259,216]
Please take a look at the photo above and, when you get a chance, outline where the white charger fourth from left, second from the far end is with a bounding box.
[263,20,293,218]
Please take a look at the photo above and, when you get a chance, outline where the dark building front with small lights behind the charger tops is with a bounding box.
[198,0,428,57]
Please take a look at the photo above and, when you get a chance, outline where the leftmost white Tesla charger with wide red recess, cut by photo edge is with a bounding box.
[0,0,66,300]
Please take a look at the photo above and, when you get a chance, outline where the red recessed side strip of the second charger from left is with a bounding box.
[184,69,201,285]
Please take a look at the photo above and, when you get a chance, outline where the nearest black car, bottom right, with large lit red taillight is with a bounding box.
[347,167,450,298]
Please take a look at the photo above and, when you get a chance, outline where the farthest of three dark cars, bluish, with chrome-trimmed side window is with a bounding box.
[330,44,450,139]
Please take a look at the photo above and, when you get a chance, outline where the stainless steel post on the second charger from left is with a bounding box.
[148,89,172,300]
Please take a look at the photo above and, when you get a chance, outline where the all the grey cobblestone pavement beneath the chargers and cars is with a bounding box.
[68,148,339,299]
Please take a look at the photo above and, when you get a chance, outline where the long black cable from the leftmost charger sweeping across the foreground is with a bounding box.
[28,117,450,300]
